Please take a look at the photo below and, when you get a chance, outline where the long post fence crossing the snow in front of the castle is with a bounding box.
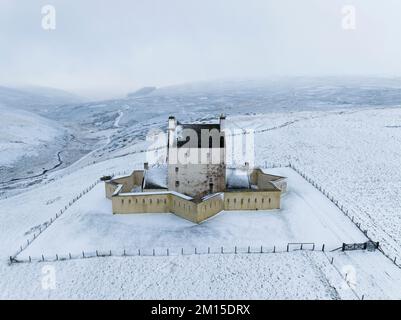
[10,243,327,263]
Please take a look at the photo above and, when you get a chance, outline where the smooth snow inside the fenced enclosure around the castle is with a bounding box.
[17,168,367,259]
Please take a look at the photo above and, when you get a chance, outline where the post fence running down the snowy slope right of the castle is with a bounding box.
[288,162,401,269]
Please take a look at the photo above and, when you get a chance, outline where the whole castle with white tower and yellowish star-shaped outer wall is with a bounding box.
[102,116,287,223]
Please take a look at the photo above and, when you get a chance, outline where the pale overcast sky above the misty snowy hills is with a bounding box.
[0,0,401,97]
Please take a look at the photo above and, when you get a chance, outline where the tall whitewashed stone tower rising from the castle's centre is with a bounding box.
[167,115,226,197]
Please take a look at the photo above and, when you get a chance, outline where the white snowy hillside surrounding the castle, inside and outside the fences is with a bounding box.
[0,82,401,299]
